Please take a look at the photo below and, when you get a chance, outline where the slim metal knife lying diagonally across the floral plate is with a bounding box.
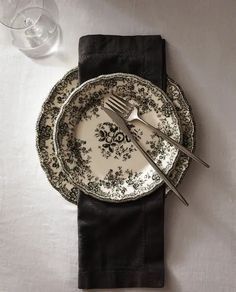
[102,105,189,206]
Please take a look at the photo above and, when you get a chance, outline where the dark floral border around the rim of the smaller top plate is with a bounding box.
[54,73,182,202]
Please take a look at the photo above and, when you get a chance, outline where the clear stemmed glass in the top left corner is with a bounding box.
[0,0,60,58]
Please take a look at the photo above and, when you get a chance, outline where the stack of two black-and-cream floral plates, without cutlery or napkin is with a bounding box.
[37,68,195,204]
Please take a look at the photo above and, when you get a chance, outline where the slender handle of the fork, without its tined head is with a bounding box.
[138,117,210,168]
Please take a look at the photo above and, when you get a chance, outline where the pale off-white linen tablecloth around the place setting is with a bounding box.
[0,0,236,292]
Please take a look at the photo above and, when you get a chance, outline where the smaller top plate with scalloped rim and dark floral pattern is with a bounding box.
[54,73,182,202]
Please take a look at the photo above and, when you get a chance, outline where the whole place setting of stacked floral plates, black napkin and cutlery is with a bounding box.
[36,35,209,289]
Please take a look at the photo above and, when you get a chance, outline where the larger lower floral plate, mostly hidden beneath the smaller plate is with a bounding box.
[36,68,195,204]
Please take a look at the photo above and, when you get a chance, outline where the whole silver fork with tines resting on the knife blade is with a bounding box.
[106,92,210,168]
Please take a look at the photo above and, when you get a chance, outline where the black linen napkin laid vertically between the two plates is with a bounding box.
[78,35,166,289]
